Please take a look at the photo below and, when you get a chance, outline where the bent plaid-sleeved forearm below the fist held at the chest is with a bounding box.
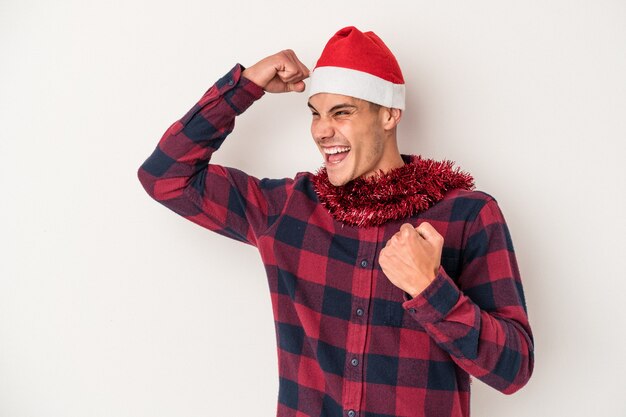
[404,269,534,394]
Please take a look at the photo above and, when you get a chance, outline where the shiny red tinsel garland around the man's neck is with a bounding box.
[313,155,474,227]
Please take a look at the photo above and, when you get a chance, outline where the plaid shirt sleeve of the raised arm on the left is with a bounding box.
[138,64,291,246]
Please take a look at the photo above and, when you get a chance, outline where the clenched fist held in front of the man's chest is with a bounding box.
[378,222,443,297]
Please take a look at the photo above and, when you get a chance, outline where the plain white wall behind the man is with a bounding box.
[0,0,626,417]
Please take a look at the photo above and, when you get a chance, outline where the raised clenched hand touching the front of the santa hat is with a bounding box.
[241,49,310,93]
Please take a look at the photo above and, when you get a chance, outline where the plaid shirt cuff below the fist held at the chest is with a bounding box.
[402,267,461,324]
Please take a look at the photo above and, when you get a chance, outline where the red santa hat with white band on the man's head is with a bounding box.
[309,26,405,109]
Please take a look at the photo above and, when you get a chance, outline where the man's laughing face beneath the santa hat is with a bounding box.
[309,93,388,186]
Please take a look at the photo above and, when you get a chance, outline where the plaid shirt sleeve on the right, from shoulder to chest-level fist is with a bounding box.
[404,195,534,394]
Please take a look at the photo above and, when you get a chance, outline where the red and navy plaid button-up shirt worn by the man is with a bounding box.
[138,65,533,417]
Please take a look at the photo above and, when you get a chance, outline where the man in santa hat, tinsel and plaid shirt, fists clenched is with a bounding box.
[139,27,533,417]
